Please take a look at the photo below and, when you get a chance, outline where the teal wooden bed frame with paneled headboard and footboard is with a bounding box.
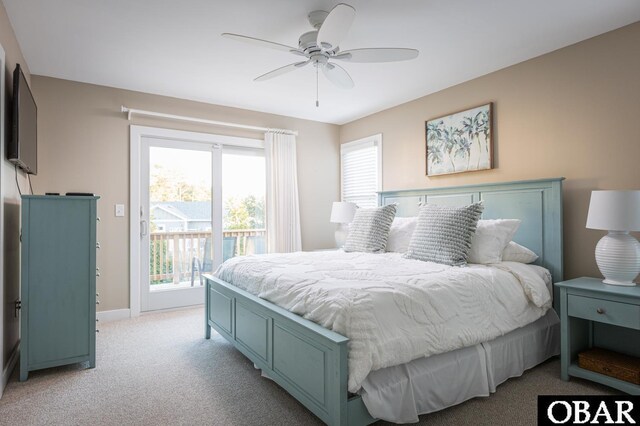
[205,178,562,425]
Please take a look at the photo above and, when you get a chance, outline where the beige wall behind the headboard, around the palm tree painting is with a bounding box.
[340,23,640,278]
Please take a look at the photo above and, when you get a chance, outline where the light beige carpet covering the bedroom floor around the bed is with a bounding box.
[0,308,614,425]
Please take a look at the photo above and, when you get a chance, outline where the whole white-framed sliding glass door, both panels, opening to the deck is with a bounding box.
[139,137,266,311]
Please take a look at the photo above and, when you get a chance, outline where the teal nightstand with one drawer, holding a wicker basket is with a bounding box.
[555,278,640,395]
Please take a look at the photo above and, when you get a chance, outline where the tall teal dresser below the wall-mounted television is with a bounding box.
[20,195,99,381]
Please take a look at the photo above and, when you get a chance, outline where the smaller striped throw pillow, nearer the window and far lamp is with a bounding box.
[344,204,396,253]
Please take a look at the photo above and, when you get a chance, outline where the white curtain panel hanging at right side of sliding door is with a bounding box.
[264,132,302,253]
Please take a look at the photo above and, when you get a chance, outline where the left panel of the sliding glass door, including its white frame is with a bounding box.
[140,138,221,311]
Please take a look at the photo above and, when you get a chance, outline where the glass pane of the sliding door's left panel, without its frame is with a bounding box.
[149,147,213,292]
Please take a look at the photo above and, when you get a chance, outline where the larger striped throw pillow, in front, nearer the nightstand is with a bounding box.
[404,203,483,266]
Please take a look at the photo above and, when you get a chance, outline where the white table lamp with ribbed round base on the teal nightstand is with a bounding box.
[587,191,640,286]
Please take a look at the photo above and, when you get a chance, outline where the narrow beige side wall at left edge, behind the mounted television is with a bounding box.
[0,2,31,380]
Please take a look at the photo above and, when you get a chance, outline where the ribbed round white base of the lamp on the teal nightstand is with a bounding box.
[596,231,640,286]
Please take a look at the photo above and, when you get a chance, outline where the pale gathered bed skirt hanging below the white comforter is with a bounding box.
[360,309,560,423]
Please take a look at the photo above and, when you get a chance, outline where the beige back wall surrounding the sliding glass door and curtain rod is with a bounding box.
[32,76,340,310]
